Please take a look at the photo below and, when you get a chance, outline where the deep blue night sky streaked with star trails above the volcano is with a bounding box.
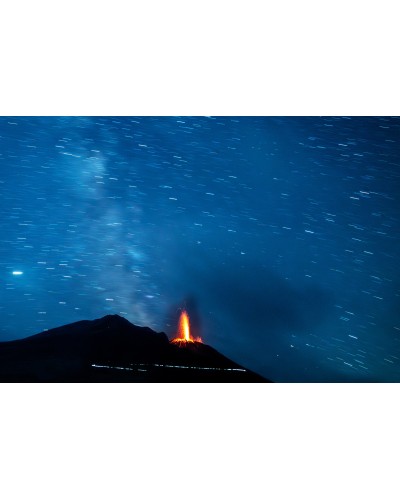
[0,116,400,382]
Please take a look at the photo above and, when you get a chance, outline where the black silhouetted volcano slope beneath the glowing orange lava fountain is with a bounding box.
[0,314,270,382]
